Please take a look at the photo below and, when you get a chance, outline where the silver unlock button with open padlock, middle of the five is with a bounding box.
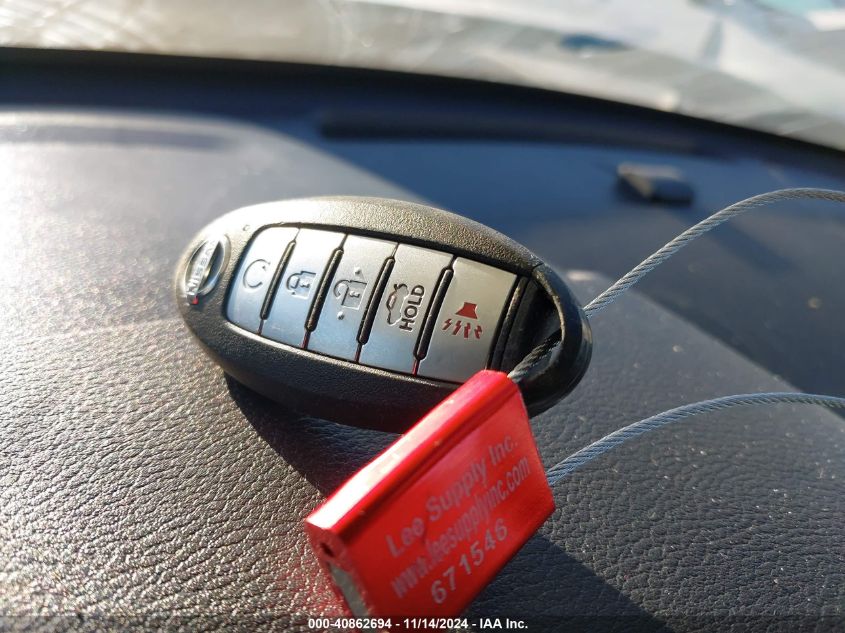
[308,235,396,360]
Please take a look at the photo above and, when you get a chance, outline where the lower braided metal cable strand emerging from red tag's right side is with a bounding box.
[546,392,845,485]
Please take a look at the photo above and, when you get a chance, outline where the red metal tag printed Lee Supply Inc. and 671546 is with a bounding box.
[306,371,554,617]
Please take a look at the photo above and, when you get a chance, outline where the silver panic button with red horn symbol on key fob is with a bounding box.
[417,259,516,382]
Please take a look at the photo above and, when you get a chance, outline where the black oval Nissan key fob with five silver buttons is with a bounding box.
[175,197,591,432]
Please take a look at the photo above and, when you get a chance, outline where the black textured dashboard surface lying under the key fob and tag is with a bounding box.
[0,54,845,631]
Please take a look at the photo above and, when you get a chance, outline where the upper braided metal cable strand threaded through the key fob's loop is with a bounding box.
[508,187,845,383]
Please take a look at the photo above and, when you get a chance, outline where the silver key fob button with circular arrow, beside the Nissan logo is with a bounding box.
[226,227,297,334]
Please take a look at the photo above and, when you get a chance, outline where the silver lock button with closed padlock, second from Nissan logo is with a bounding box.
[261,229,344,347]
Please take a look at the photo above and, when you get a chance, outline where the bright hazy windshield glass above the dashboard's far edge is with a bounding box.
[0,0,845,149]
